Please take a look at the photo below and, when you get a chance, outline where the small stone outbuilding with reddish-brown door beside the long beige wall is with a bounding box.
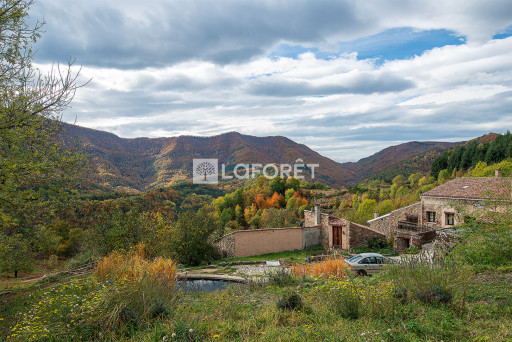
[304,204,385,250]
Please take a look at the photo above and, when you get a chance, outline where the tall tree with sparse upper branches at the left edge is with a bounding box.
[0,0,81,272]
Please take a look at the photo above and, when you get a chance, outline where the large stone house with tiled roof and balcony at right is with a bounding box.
[368,169,511,252]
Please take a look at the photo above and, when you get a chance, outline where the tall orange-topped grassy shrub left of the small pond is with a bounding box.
[91,244,176,335]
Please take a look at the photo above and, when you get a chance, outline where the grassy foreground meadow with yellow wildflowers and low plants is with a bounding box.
[0,253,512,342]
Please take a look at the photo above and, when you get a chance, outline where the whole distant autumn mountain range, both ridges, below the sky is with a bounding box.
[63,124,460,191]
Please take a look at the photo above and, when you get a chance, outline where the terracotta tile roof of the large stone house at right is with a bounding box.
[421,177,512,200]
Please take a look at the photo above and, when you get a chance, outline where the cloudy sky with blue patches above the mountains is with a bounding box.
[31,0,512,161]
